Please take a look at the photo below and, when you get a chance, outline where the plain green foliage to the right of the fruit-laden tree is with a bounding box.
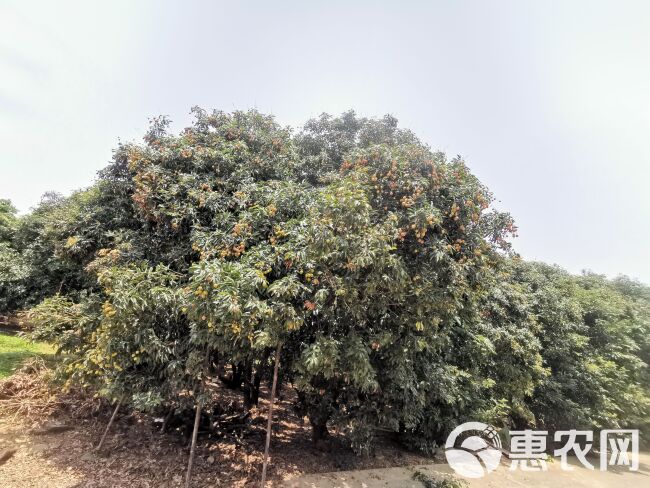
[514,264,650,429]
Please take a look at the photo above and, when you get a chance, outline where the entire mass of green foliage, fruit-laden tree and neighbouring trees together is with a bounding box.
[0,109,650,452]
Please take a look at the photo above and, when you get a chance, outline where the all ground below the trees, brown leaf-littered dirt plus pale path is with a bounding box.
[0,372,650,488]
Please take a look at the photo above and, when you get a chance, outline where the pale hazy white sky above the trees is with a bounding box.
[0,0,650,283]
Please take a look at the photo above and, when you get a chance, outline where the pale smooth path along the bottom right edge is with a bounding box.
[282,452,650,488]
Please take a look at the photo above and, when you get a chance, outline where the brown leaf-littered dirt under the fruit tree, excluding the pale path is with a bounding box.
[0,370,432,488]
